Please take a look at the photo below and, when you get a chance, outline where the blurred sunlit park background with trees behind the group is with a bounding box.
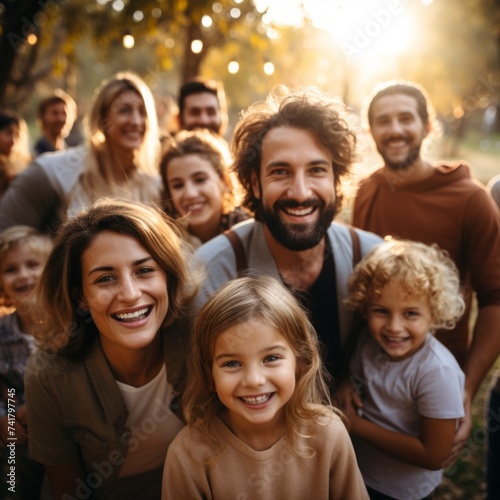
[0,0,500,499]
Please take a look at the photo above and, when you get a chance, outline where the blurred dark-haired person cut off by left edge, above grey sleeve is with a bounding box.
[0,110,31,197]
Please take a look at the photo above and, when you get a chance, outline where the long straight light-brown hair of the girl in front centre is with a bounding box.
[183,276,331,454]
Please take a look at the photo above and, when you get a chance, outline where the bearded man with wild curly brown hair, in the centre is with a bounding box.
[189,86,381,377]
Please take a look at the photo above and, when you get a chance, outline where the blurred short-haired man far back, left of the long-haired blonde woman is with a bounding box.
[33,89,76,155]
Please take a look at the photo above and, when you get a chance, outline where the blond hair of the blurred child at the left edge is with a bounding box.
[0,226,52,302]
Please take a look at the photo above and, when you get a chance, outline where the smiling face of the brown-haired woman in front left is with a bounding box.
[82,231,169,352]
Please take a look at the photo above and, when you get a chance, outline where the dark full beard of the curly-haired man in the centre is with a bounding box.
[261,199,337,252]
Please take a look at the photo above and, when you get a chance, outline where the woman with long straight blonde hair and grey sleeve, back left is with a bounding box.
[0,72,161,231]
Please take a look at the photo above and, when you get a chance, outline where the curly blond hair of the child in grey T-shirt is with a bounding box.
[346,239,465,330]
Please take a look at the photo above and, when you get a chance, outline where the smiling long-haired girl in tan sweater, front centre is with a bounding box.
[163,277,368,500]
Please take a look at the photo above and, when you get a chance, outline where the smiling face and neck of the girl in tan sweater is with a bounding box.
[212,321,296,446]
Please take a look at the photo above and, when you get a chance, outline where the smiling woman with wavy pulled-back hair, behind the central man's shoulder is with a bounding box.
[160,130,250,248]
